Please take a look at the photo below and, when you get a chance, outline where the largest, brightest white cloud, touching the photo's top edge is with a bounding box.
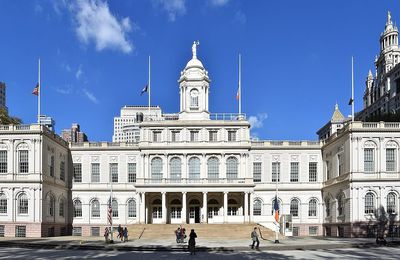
[70,0,133,53]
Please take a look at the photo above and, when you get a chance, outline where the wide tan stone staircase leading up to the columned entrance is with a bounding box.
[128,224,275,240]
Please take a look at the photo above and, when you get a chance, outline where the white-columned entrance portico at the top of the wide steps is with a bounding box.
[138,190,253,224]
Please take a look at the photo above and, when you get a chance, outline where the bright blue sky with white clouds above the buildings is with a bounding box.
[0,0,400,141]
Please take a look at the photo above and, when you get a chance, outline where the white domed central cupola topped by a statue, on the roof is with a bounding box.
[178,41,210,120]
